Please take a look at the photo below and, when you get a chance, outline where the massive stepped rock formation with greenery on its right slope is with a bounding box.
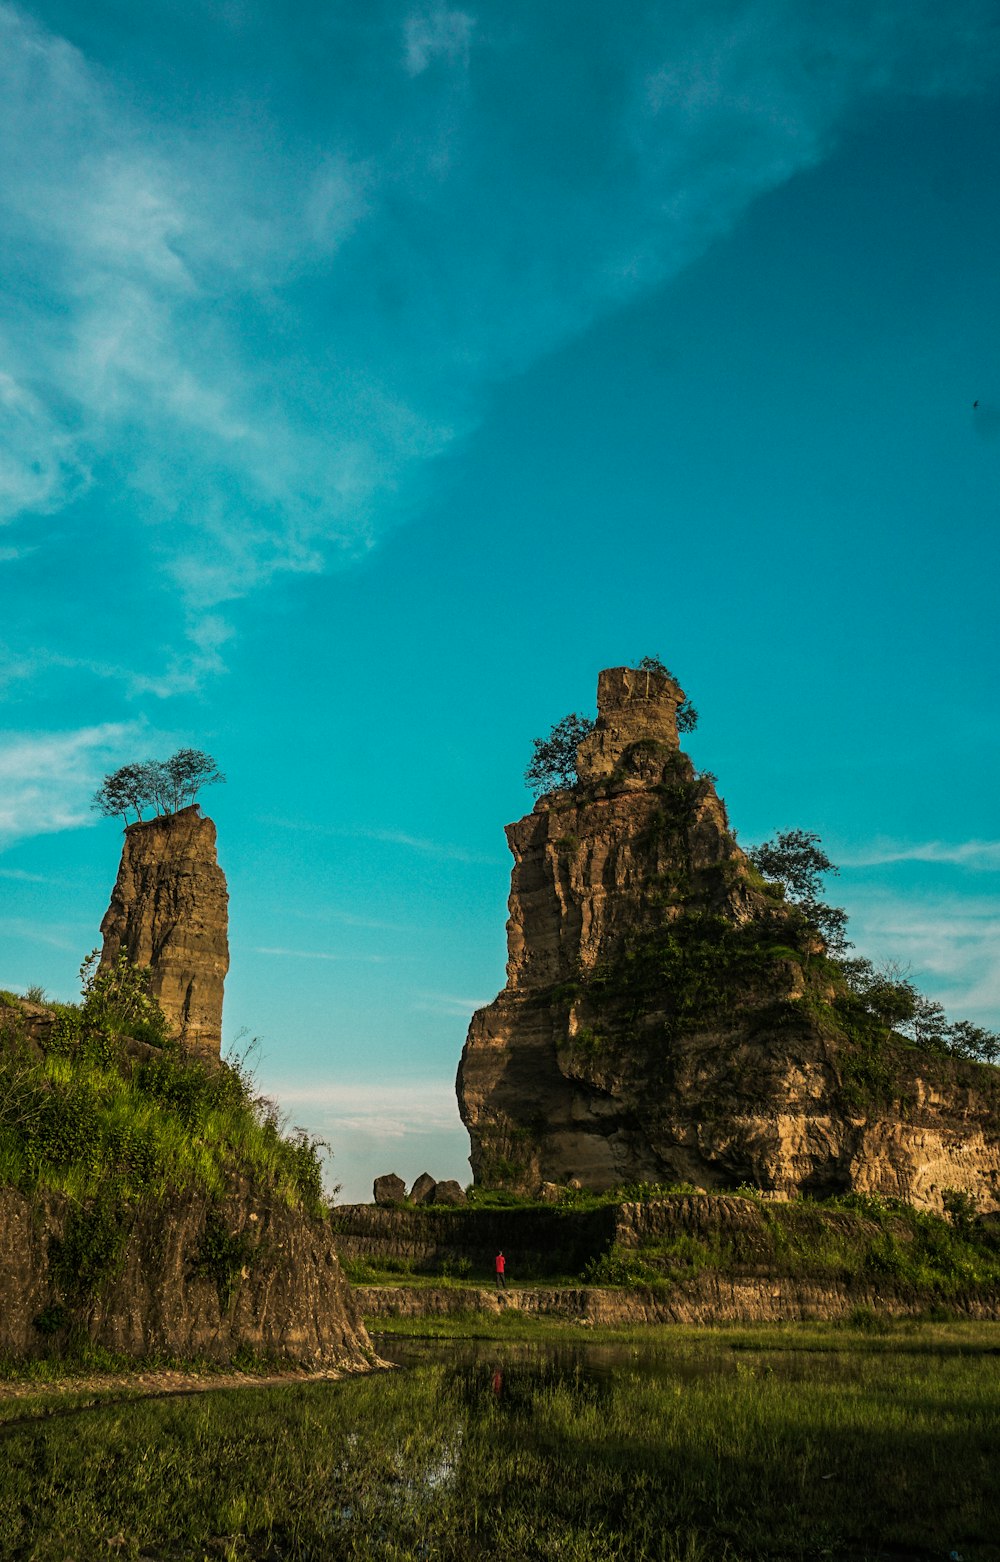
[458,667,1000,1211]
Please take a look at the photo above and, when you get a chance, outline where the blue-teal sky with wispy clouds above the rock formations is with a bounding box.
[0,0,1000,1200]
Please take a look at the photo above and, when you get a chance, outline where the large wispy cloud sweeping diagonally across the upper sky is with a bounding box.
[0,0,1000,687]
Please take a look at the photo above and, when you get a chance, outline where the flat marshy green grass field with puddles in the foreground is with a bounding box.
[0,1325,1000,1562]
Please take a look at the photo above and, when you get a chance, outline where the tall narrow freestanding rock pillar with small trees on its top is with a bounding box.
[100,803,230,1057]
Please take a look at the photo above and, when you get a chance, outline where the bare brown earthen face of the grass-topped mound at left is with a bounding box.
[0,1187,372,1370]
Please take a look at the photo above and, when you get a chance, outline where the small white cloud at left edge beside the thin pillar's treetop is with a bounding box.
[0,722,142,845]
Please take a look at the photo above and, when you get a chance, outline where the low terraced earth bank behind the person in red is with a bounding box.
[331,1193,1000,1323]
